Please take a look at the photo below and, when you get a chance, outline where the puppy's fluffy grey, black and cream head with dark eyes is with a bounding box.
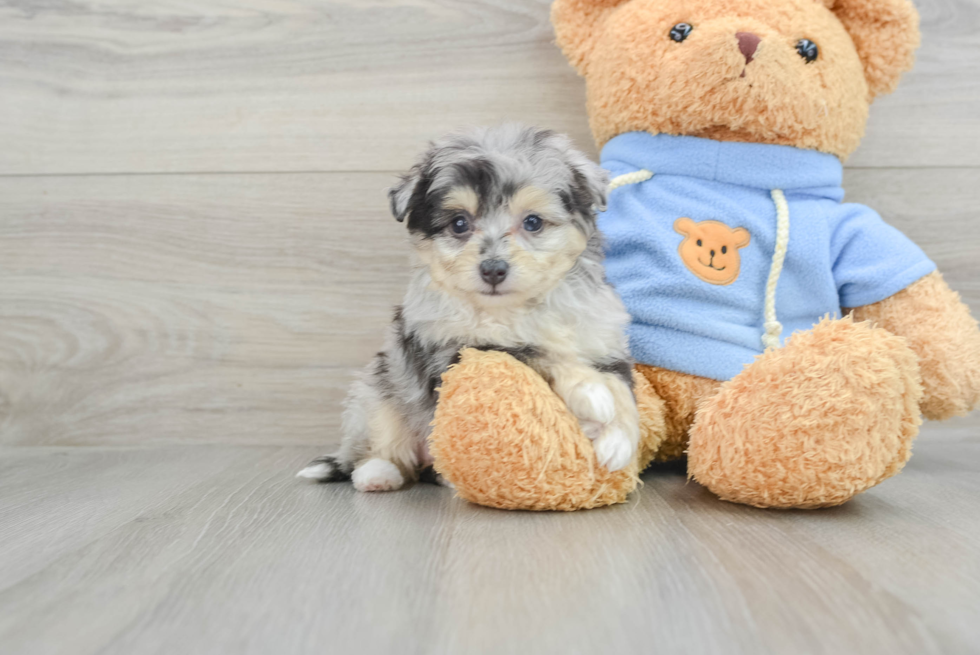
[391,126,607,306]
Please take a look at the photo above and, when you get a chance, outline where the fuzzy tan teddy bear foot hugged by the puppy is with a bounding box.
[429,349,663,510]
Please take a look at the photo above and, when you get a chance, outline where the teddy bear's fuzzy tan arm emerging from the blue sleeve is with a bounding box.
[851,272,980,420]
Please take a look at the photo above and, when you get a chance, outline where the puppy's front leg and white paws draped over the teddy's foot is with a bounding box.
[545,362,640,471]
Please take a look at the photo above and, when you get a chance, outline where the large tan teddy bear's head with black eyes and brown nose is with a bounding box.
[552,0,919,159]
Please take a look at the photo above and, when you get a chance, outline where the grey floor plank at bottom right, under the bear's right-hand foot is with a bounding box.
[664,436,980,653]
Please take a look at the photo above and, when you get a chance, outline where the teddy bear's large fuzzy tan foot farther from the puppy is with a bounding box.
[688,317,922,508]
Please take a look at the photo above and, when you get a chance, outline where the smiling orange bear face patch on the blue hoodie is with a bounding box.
[674,218,752,285]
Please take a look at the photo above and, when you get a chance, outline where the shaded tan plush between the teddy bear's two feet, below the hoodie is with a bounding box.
[636,364,721,470]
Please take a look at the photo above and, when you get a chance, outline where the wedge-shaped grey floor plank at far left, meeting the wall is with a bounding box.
[0,447,272,592]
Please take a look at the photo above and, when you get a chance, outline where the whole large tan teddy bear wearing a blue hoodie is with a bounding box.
[430,0,980,510]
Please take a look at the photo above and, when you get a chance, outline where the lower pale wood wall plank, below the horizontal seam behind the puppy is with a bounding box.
[0,169,980,445]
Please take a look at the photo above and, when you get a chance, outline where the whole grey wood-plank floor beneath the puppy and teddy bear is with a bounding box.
[0,440,980,655]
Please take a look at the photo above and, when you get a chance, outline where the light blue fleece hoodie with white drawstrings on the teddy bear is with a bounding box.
[599,132,936,380]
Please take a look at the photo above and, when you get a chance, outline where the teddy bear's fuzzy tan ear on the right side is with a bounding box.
[823,0,920,98]
